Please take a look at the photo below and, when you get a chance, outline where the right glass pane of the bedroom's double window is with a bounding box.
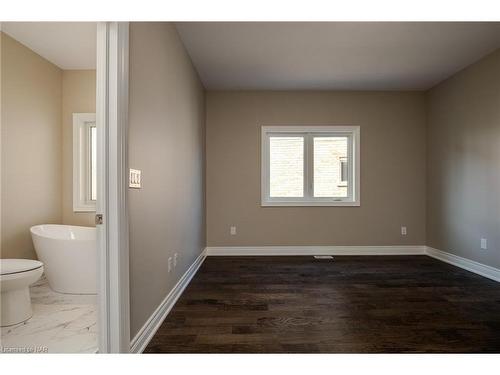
[313,137,348,198]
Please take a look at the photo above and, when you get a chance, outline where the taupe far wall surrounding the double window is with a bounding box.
[206,91,425,246]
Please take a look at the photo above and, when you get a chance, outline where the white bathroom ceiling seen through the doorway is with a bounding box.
[2,22,97,70]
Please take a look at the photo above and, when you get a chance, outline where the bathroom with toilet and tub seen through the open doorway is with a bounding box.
[0,22,99,353]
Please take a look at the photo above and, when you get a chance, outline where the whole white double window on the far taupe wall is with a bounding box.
[261,126,360,206]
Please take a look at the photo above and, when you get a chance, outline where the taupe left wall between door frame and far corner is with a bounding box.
[129,23,205,337]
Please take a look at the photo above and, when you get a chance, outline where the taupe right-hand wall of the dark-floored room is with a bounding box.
[427,50,500,267]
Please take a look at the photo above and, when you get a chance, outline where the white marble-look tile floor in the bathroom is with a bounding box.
[0,277,98,353]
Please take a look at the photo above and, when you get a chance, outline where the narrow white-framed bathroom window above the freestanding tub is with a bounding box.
[73,113,97,212]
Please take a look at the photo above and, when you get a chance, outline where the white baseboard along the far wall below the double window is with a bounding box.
[206,246,426,256]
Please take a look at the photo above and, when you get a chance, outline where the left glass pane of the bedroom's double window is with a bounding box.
[269,137,304,197]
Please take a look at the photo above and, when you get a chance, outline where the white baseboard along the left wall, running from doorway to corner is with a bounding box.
[130,250,206,353]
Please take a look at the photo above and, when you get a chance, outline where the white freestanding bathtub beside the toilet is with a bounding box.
[31,224,97,294]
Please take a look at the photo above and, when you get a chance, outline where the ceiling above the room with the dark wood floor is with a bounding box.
[176,22,500,90]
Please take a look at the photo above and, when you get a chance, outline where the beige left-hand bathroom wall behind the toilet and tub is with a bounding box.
[1,34,62,258]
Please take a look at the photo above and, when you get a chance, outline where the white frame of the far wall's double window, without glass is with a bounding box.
[261,126,361,206]
